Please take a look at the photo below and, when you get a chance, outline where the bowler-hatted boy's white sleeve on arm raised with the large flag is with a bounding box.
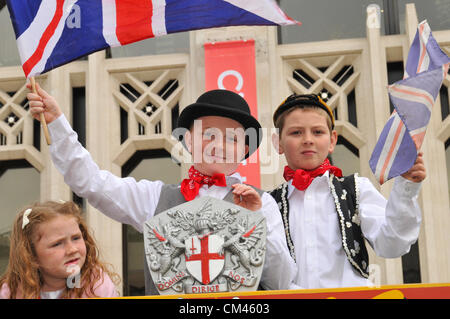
[48,115,163,232]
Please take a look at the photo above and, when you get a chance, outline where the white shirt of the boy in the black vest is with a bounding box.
[288,172,421,289]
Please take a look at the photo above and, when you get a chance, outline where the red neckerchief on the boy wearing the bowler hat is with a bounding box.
[181,166,227,201]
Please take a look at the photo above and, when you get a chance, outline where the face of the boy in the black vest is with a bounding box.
[279,109,337,170]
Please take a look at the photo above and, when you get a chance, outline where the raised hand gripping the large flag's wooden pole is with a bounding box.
[27,83,62,123]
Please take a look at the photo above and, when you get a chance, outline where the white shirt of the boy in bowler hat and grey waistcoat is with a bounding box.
[48,115,297,289]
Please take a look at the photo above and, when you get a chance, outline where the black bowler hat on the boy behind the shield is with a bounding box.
[177,90,262,158]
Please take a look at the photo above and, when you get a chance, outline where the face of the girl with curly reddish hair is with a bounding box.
[33,215,86,291]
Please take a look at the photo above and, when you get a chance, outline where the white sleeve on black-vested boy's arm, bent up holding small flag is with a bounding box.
[358,176,422,258]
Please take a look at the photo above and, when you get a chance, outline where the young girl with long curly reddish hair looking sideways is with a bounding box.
[0,201,119,299]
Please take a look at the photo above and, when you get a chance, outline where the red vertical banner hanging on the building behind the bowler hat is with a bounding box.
[205,40,261,187]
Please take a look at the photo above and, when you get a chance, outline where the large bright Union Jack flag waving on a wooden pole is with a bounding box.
[7,0,298,77]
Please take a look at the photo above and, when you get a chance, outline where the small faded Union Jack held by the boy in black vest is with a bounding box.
[369,20,450,184]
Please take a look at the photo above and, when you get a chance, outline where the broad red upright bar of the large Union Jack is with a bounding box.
[116,0,155,45]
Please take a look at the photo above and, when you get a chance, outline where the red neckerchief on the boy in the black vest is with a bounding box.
[283,159,342,191]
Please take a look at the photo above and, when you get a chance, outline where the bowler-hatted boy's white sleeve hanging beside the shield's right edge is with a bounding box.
[261,193,300,290]
